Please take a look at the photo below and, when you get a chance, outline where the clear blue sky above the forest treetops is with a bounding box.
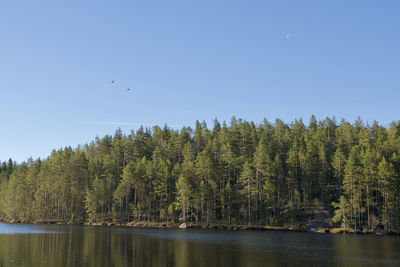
[0,0,400,162]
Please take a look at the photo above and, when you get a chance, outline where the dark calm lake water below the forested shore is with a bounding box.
[0,223,400,267]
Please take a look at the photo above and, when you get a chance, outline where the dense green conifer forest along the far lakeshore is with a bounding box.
[0,117,400,231]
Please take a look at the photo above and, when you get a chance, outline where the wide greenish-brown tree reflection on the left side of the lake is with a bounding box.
[0,228,260,267]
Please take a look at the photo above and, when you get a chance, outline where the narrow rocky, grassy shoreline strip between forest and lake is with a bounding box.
[0,218,400,235]
